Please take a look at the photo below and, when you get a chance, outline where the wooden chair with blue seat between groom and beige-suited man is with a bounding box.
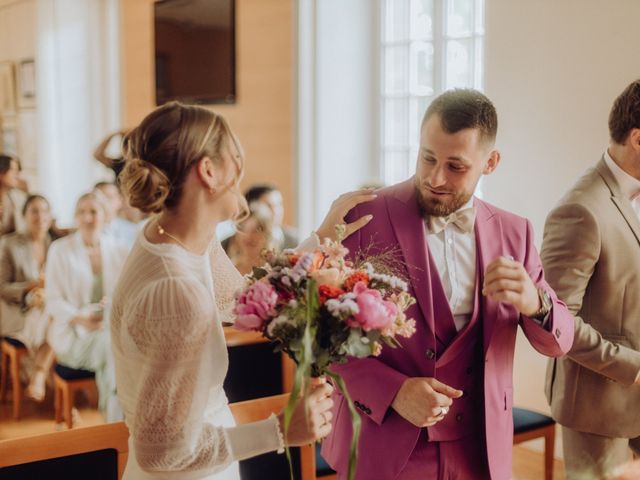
[513,407,556,480]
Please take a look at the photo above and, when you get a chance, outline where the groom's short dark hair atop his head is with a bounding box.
[422,88,498,142]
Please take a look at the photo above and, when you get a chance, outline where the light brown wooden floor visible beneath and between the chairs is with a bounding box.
[0,399,565,480]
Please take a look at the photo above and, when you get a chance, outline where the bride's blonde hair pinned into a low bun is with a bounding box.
[118,102,248,218]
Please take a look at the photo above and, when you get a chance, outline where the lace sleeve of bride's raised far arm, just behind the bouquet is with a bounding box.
[211,241,245,323]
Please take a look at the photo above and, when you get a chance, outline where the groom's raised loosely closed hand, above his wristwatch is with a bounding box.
[482,257,540,317]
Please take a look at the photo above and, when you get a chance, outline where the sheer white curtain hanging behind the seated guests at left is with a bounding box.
[32,0,122,226]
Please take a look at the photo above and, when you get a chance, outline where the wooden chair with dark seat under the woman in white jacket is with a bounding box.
[53,365,98,429]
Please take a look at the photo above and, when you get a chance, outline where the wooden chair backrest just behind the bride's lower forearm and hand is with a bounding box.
[229,393,316,480]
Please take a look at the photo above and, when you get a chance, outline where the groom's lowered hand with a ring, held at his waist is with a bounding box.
[391,377,462,428]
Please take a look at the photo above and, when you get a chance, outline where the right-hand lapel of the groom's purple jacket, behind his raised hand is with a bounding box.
[474,199,502,354]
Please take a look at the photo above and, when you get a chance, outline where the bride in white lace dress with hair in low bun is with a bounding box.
[111,103,373,480]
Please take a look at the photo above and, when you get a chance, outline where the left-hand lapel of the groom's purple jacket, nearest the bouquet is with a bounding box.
[387,177,435,333]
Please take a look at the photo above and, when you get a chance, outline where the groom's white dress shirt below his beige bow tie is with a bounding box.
[425,197,476,331]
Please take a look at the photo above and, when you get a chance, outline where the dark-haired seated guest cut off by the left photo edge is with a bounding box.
[0,154,27,235]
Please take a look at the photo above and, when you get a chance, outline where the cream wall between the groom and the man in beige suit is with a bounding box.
[484,0,640,454]
